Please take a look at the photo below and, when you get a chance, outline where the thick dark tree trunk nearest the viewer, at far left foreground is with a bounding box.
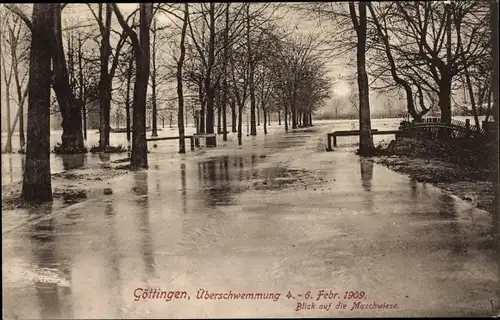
[22,3,54,202]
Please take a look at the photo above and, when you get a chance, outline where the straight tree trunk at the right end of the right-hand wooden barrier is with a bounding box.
[349,1,374,156]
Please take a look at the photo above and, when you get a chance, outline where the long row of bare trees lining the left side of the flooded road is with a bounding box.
[2,3,330,202]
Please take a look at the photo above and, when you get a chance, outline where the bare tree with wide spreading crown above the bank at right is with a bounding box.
[378,1,488,122]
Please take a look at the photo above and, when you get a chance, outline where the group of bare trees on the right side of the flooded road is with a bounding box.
[295,0,498,154]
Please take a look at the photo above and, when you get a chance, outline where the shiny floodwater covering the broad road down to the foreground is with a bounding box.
[2,119,499,319]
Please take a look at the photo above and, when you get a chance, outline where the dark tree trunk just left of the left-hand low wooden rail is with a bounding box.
[130,3,153,170]
